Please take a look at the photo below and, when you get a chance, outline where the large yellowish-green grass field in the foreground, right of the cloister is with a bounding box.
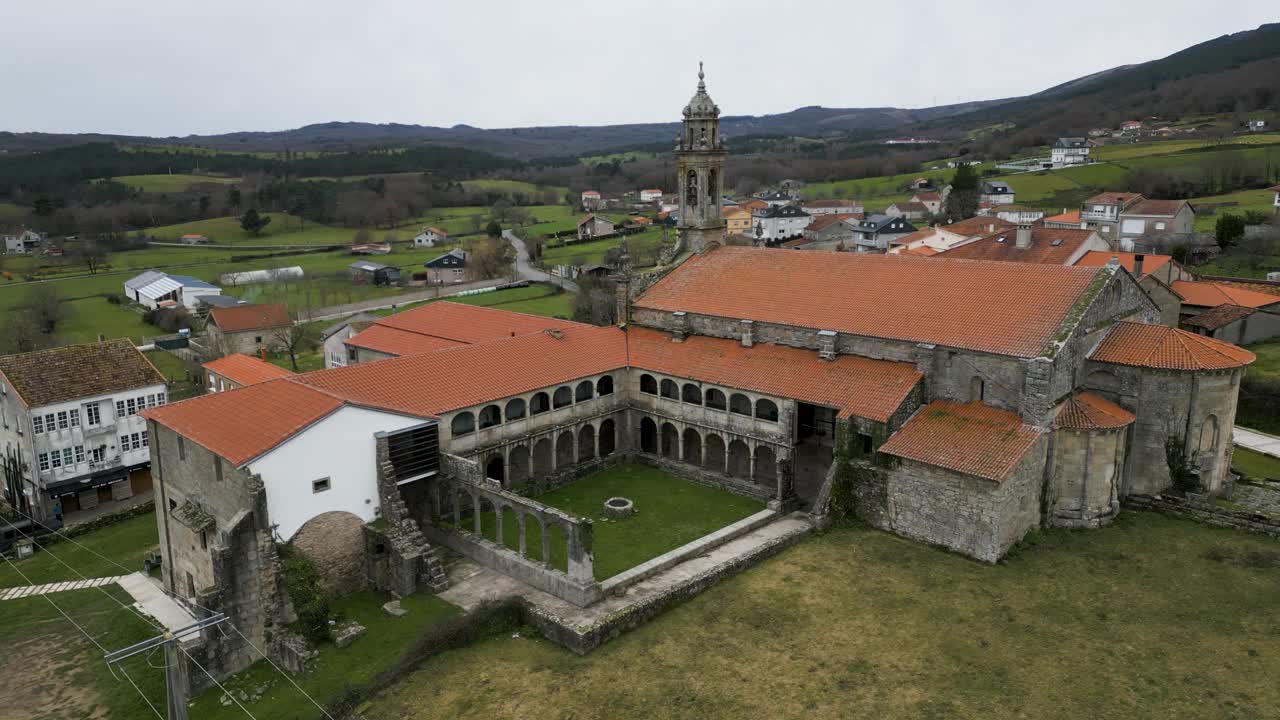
[361,511,1280,720]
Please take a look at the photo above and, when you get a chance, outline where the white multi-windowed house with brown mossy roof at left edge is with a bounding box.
[0,338,168,517]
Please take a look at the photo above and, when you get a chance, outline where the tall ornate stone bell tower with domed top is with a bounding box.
[676,63,727,254]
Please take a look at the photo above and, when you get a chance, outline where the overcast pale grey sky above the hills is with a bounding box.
[0,0,1280,136]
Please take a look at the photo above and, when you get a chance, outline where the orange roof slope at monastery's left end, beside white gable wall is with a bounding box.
[142,379,342,466]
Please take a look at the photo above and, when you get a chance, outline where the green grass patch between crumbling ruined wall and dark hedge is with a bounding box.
[183,591,460,720]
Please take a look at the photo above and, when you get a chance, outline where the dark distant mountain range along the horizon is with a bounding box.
[0,24,1280,159]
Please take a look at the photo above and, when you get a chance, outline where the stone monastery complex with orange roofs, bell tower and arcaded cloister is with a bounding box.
[135,65,1254,675]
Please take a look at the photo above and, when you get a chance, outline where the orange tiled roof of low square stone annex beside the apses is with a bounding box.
[879,400,1039,483]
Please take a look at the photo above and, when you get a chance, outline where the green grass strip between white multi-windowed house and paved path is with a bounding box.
[0,512,160,586]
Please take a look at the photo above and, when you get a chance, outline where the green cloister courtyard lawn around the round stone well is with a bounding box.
[450,465,764,580]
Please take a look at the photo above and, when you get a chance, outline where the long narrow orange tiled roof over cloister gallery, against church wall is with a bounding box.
[627,327,923,423]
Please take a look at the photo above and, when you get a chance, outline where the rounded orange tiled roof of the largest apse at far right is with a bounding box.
[1089,320,1254,370]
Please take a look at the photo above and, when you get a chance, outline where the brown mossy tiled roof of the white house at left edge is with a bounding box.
[0,338,165,407]
